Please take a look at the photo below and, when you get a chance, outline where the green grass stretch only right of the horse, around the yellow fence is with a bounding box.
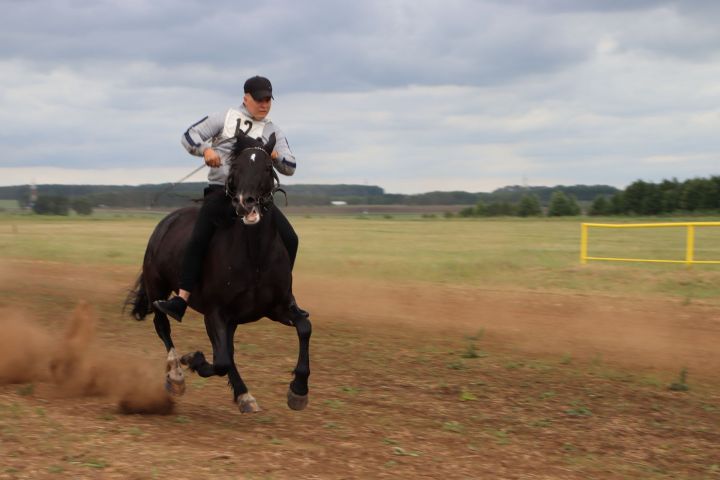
[294,218,720,299]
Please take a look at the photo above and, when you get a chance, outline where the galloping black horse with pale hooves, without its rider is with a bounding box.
[128,134,312,412]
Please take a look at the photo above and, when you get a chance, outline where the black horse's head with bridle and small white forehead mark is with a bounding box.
[225,133,280,225]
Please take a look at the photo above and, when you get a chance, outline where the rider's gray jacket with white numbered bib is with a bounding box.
[182,105,296,185]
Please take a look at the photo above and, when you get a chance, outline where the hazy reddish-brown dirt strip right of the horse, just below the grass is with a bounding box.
[298,277,720,379]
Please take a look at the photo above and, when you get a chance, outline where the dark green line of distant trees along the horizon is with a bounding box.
[7,176,720,217]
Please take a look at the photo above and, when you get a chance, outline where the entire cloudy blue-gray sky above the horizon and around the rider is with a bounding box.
[0,0,720,193]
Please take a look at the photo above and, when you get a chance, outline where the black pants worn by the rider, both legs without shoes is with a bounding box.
[180,185,299,292]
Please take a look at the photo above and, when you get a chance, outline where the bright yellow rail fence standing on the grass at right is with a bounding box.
[580,222,720,266]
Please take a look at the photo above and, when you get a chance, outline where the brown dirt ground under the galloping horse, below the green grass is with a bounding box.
[0,261,720,479]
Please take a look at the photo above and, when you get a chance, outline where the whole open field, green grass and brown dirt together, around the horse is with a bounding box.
[0,213,720,480]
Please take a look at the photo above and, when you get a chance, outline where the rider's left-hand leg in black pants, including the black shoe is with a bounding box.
[153,185,229,321]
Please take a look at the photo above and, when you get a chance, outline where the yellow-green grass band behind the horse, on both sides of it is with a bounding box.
[0,213,720,304]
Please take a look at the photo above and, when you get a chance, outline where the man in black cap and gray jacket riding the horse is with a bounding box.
[153,76,308,321]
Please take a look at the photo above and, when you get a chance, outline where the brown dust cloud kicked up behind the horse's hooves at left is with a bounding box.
[0,302,174,414]
